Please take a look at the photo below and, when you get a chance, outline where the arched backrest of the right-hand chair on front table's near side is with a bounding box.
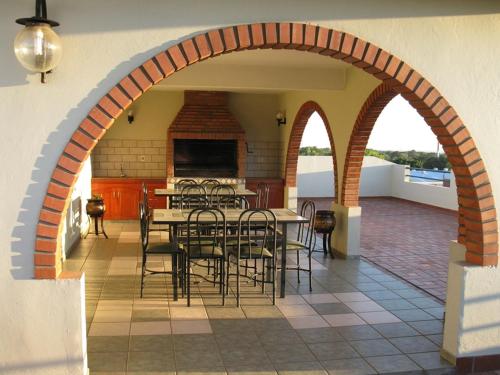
[238,208,278,259]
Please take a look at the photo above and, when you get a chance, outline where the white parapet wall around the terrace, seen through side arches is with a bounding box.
[297,156,458,210]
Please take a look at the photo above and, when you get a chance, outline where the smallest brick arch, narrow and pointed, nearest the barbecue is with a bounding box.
[285,101,338,202]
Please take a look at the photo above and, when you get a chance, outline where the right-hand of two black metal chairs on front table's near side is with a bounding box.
[226,208,277,306]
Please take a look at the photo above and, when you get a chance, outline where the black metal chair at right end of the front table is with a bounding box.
[279,200,316,291]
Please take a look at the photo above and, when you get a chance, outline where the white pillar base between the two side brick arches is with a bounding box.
[332,203,361,258]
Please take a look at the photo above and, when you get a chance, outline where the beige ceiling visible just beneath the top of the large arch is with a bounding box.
[156,49,350,92]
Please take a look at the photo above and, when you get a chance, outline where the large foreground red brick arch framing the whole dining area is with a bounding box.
[34,23,498,278]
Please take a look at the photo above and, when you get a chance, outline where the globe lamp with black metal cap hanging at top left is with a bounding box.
[14,0,62,83]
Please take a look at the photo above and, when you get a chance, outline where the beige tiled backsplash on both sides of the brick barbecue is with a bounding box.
[92,139,282,177]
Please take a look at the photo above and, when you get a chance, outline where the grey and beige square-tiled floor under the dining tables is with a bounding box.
[61,222,454,375]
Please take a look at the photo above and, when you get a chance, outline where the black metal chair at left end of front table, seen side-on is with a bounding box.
[139,202,185,300]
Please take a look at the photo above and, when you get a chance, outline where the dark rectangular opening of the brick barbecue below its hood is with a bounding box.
[174,139,238,177]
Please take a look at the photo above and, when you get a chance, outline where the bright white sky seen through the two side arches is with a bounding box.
[300,95,437,152]
